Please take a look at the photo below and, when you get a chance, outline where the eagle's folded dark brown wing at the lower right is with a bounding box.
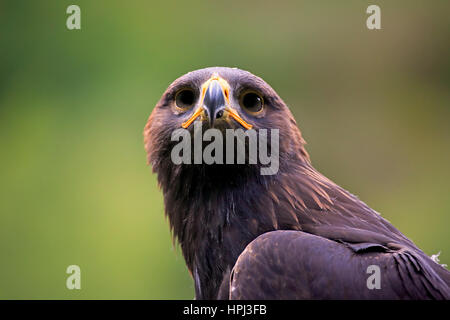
[229,231,450,299]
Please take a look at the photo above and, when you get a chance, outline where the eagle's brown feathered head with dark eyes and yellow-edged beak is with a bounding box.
[144,67,309,187]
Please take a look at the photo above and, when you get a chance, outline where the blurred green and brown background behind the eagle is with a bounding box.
[0,0,450,299]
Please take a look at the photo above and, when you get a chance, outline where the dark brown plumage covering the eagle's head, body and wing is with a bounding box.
[144,68,450,299]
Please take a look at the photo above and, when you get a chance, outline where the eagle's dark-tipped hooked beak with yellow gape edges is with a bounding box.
[181,74,253,130]
